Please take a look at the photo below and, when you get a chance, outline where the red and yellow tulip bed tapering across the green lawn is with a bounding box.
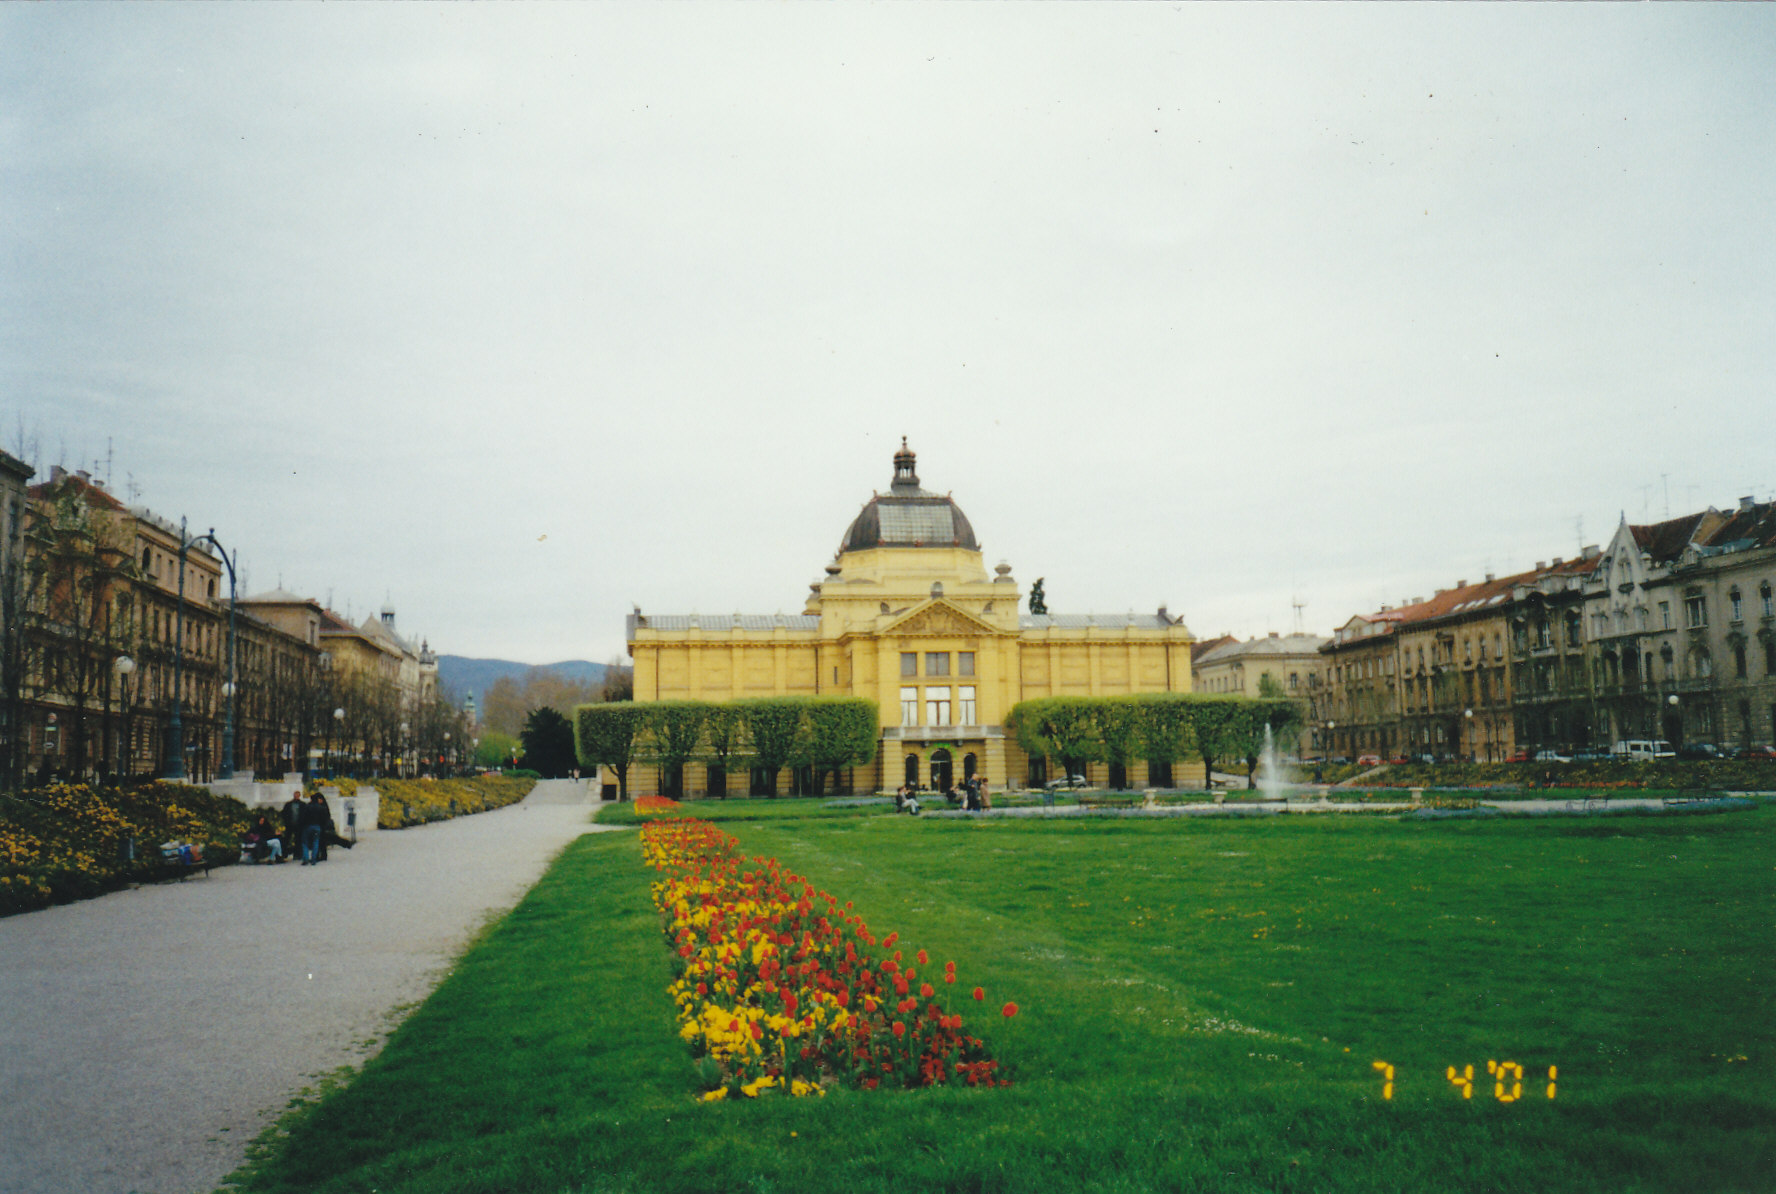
[641,817,1018,1100]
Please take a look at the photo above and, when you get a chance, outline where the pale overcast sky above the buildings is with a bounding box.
[0,4,1776,663]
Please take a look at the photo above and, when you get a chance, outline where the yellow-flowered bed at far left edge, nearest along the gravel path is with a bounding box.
[0,782,250,915]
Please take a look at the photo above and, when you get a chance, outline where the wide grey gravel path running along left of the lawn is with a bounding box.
[0,780,625,1194]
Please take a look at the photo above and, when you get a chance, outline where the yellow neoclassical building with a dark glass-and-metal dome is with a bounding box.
[627,441,1201,792]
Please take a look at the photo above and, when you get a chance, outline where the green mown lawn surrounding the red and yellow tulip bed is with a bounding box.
[229,801,1776,1194]
